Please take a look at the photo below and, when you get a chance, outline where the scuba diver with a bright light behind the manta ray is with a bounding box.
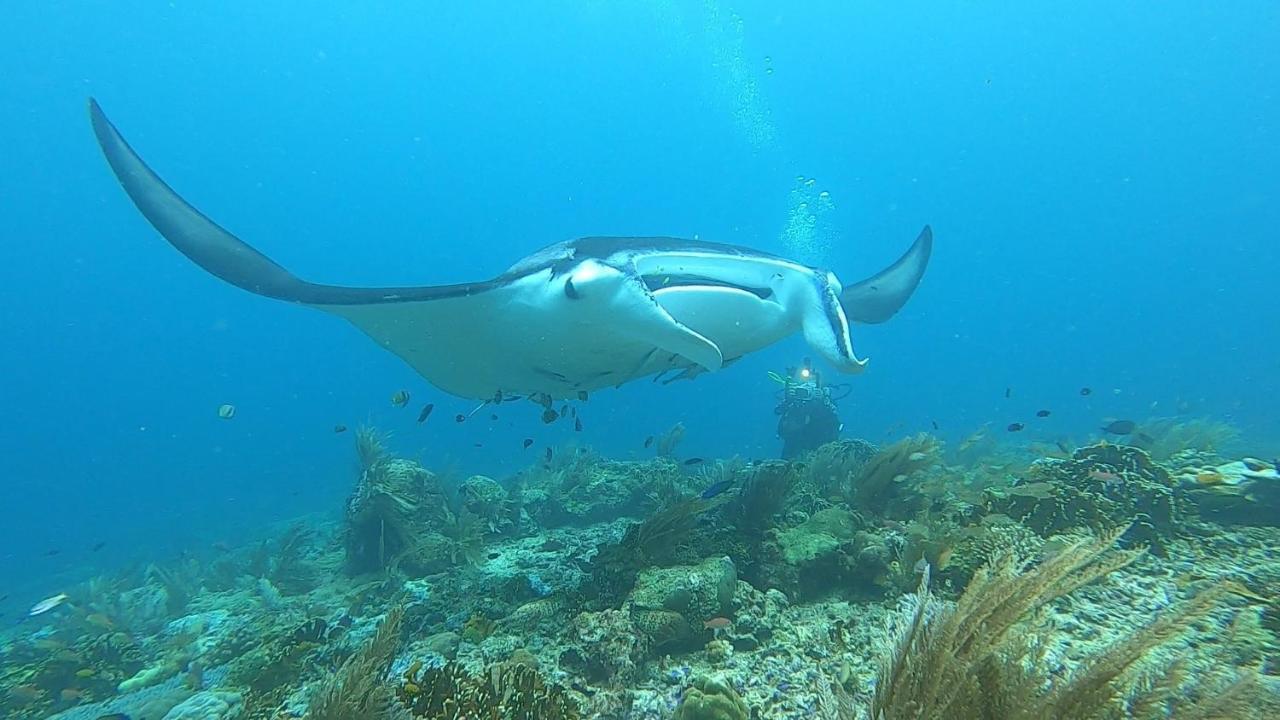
[769,357,851,460]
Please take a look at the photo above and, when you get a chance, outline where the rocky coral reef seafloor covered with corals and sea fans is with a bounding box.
[0,422,1280,720]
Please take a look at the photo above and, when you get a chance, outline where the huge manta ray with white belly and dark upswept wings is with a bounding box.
[90,100,933,400]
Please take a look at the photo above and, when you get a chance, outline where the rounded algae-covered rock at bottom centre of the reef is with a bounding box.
[630,557,737,624]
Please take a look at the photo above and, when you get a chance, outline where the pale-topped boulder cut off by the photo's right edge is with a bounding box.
[1178,457,1280,525]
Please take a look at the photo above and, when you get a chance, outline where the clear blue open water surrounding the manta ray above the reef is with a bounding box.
[0,0,1280,604]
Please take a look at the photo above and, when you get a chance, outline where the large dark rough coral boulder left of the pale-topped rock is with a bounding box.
[987,442,1177,555]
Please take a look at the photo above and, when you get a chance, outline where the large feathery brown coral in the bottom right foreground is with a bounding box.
[869,525,1275,720]
